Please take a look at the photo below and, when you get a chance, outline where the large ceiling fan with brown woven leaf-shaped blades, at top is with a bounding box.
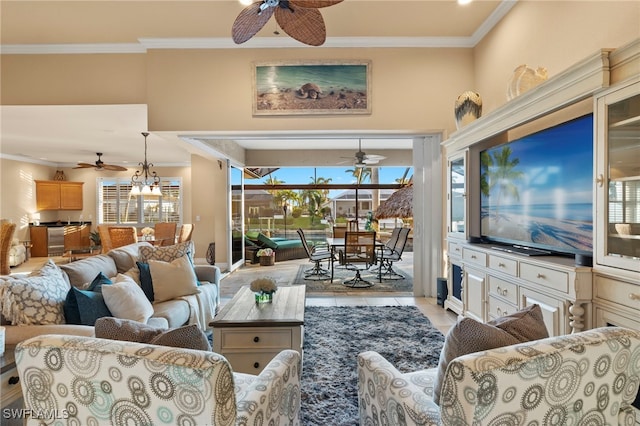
[231,0,343,46]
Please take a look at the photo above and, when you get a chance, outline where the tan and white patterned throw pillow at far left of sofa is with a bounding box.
[1,259,71,325]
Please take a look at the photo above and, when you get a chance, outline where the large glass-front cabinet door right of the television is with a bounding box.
[596,82,640,271]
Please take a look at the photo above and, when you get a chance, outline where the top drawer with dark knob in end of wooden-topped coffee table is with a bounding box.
[221,328,293,351]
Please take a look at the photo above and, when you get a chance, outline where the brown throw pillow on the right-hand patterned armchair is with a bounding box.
[433,305,549,405]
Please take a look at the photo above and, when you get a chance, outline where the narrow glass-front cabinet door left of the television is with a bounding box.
[447,151,467,239]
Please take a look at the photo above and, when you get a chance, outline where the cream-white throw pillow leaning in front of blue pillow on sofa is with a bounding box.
[102,274,153,323]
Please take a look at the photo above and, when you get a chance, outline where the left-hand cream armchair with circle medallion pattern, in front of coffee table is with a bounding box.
[16,335,301,426]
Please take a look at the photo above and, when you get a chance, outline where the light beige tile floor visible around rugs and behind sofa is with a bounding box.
[11,253,457,334]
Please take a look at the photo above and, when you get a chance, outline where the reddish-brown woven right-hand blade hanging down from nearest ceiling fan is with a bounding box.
[275,3,327,46]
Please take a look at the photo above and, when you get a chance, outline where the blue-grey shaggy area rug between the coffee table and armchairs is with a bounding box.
[302,306,444,426]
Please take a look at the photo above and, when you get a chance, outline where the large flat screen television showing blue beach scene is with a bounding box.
[480,114,593,256]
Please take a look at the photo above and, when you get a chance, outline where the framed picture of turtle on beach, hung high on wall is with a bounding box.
[253,61,371,115]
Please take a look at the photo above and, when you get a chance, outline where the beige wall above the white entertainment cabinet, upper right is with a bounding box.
[474,0,640,114]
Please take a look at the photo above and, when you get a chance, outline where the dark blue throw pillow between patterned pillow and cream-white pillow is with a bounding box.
[63,272,111,325]
